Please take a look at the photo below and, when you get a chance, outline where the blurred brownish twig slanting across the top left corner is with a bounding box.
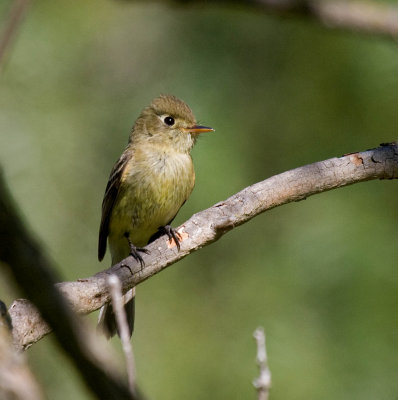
[0,0,30,72]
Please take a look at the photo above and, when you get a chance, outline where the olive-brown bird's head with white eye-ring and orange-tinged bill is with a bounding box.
[130,95,214,152]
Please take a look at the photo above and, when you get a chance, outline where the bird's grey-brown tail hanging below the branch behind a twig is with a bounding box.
[97,287,135,339]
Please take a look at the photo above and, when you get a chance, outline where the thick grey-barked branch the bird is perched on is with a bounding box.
[9,143,398,346]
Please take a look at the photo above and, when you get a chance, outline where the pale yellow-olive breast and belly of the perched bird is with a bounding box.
[109,152,195,262]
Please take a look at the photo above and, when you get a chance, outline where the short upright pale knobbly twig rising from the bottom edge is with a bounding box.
[253,327,271,400]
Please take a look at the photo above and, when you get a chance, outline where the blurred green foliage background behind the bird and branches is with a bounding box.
[0,0,398,400]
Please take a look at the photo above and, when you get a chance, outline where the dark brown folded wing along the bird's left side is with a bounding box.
[98,151,132,261]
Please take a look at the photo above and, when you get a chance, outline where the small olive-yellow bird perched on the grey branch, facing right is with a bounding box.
[98,95,214,338]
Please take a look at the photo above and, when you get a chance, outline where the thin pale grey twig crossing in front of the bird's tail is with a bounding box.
[107,275,136,393]
